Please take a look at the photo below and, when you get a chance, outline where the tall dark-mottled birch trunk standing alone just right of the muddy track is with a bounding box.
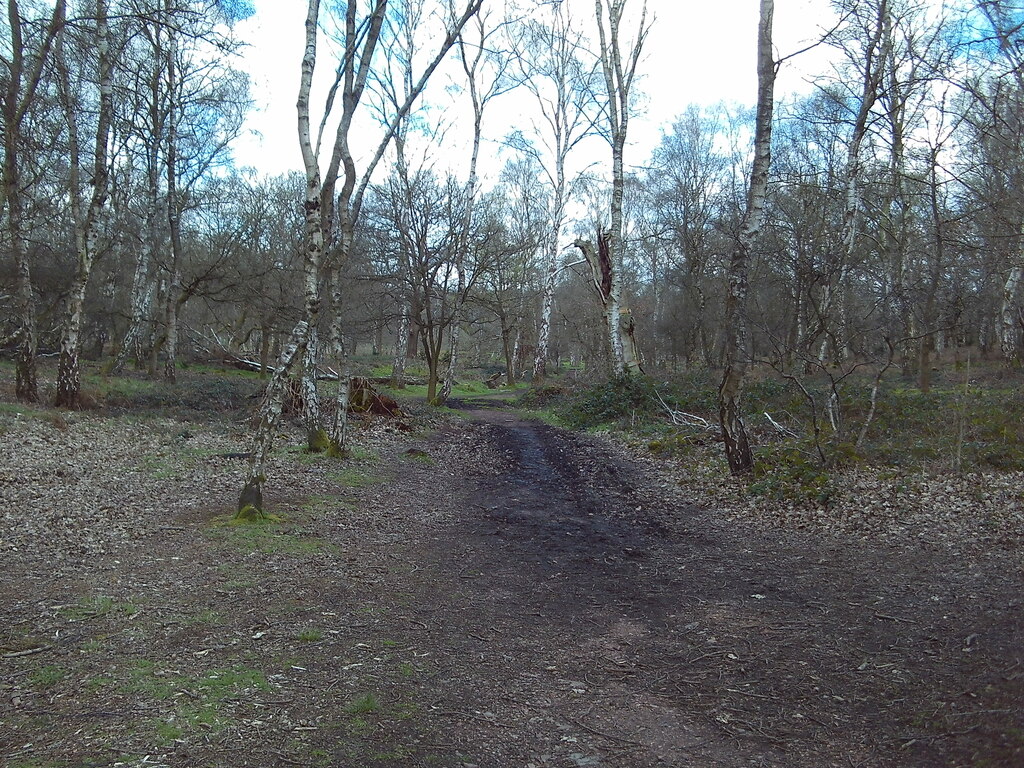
[718,0,775,474]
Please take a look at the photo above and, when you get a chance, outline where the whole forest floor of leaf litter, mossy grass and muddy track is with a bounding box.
[0,374,1024,768]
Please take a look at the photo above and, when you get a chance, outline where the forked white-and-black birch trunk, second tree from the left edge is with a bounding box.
[55,0,114,408]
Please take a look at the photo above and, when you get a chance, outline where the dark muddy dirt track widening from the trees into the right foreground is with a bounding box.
[378,410,1022,766]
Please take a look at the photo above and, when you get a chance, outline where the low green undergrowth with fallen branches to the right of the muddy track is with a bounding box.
[518,370,1024,504]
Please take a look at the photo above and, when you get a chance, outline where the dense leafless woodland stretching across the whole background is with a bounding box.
[6,0,1024,493]
